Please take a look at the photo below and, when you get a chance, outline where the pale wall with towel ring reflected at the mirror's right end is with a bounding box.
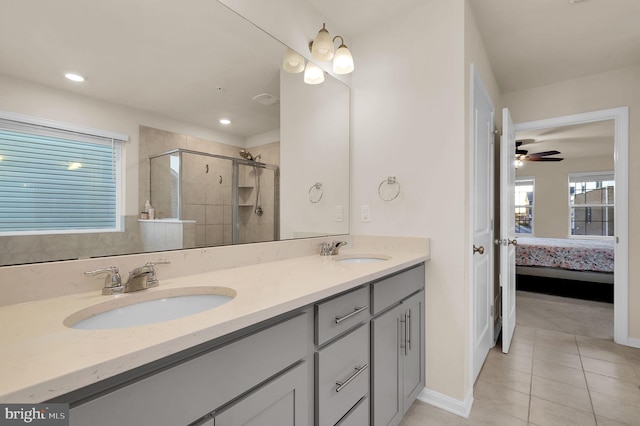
[280,71,350,239]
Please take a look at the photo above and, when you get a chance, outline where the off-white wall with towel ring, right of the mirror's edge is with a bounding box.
[350,0,468,400]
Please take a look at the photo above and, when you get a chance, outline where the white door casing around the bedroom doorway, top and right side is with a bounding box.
[515,107,640,347]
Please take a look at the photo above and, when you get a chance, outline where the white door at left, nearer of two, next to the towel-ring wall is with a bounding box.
[470,68,494,382]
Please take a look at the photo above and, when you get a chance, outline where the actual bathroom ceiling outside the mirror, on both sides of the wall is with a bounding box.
[316,0,640,93]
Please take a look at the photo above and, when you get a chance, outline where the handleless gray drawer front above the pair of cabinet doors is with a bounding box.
[371,263,424,315]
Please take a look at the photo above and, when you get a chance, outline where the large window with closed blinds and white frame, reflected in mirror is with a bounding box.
[0,112,128,235]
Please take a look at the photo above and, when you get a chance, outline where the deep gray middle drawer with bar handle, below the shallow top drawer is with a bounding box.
[315,323,369,426]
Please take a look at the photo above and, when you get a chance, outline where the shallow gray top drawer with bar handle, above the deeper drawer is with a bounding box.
[316,286,369,345]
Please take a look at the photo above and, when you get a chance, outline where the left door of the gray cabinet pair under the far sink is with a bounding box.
[371,305,404,426]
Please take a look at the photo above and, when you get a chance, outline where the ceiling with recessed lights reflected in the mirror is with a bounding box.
[0,0,286,137]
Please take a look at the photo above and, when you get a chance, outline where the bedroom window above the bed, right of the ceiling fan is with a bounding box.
[569,172,615,237]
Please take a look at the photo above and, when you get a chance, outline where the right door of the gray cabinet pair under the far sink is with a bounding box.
[401,291,424,414]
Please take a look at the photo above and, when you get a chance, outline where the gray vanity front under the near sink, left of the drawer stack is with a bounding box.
[70,309,313,426]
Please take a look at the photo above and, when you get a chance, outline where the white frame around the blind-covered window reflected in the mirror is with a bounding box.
[0,110,129,236]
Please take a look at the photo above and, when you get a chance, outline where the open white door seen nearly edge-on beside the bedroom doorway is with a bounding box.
[499,108,516,353]
